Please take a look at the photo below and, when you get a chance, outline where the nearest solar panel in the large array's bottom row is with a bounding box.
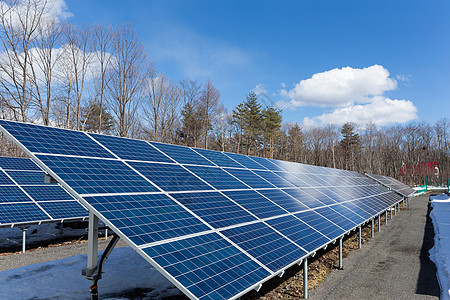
[143,233,270,300]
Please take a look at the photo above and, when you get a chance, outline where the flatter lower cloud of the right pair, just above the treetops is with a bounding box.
[303,96,417,127]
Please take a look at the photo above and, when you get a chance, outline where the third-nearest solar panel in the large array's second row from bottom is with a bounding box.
[223,190,287,219]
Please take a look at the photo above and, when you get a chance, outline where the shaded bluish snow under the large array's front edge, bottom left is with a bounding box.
[0,247,181,299]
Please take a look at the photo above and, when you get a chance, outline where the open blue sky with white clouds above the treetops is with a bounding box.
[66,0,450,125]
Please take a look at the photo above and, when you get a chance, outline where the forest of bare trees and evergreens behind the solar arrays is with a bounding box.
[0,0,450,185]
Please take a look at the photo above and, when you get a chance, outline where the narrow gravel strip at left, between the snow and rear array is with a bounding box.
[0,238,128,272]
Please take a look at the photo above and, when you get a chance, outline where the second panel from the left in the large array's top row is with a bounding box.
[89,134,173,162]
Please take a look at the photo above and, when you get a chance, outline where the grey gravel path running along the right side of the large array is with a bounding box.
[310,196,439,299]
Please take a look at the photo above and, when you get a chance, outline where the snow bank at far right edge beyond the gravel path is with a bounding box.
[429,194,450,300]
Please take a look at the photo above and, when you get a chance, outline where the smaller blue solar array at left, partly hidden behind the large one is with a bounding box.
[0,157,87,226]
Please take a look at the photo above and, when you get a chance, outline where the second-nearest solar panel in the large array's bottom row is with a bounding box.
[222,223,307,272]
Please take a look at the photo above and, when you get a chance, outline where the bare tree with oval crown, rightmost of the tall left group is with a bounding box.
[107,25,150,137]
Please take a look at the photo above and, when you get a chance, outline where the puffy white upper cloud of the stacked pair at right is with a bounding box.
[279,65,397,108]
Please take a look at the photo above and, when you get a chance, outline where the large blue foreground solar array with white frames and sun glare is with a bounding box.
[0,120,402,299]
